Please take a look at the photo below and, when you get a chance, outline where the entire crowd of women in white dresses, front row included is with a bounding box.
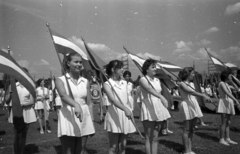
[1,53,240,154]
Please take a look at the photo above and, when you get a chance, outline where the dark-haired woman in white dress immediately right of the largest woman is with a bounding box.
[103,60,136,154]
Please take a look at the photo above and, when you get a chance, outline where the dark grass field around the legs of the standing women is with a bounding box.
[0,106,240,154]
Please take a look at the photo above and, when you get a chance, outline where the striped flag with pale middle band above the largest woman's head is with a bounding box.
[49,27,92,69]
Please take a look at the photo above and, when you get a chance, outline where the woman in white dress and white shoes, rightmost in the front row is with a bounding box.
[217,71,240,146]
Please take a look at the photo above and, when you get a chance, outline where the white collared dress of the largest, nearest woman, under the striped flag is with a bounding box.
[58,73,95,137]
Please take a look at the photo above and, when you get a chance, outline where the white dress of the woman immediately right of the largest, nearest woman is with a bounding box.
[104,78,136,134]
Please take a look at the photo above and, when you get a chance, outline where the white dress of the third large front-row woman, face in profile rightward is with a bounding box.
[140,76,171,121]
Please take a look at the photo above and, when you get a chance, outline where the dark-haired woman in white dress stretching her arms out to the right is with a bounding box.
[178,67,211,154]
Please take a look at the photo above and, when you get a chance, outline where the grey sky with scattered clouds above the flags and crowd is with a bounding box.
[0,0,240,78]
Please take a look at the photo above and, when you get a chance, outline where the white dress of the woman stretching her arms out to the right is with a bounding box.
[179,82,203,121]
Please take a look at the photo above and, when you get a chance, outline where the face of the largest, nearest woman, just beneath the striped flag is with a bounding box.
[67,55,82,72]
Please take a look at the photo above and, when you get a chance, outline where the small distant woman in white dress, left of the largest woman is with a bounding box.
[34,78,51,134]
